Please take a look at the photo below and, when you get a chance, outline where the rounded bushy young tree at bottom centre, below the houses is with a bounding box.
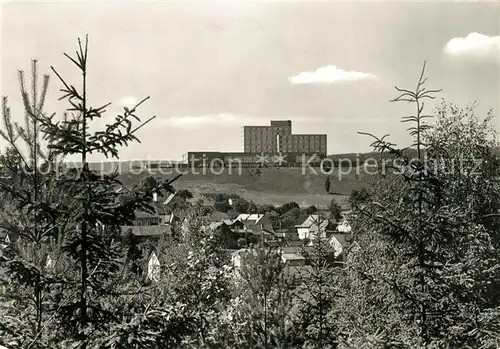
[227,248,295,348]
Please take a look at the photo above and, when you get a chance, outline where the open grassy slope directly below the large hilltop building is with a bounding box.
[116,168,370,206]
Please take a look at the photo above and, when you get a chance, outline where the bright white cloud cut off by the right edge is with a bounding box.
[444,33,500,59]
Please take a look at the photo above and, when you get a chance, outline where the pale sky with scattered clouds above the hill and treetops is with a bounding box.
[0,0,500,160]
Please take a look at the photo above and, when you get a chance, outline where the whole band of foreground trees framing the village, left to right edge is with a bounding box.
[0,36,500,349]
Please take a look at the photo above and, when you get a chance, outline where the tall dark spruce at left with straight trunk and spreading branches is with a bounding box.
[35,34,172,348]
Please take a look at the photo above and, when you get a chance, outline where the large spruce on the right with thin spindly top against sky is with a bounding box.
[344,61,498,348]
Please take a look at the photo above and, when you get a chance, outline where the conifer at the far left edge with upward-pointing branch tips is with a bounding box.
[0,60,67,347]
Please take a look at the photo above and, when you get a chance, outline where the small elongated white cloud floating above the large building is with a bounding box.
[288,65,377,84]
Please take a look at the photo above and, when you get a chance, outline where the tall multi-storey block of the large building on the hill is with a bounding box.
[243,120,327,155]
